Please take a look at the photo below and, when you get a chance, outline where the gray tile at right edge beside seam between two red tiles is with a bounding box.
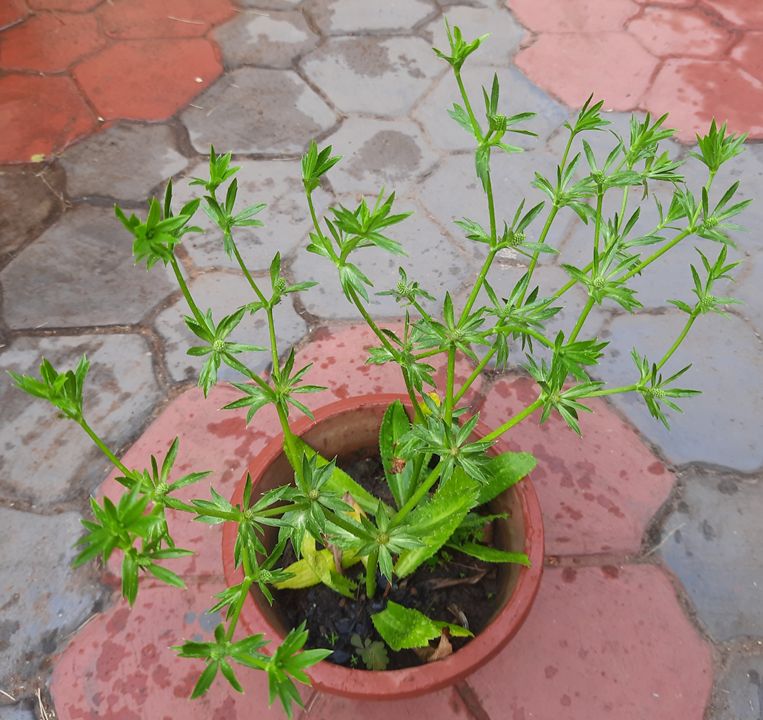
[660,471,763,641]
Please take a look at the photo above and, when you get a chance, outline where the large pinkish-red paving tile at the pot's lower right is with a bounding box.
[468,565,713,720]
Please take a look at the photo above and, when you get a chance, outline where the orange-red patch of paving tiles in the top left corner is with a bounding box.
[0,0,235,164]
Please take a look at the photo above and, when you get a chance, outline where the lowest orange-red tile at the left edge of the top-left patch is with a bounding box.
[0,74,96,163]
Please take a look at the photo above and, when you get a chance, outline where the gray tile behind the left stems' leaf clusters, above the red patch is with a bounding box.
[155,272,307,382]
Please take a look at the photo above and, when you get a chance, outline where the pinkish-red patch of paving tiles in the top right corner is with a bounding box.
[507,0,763,142]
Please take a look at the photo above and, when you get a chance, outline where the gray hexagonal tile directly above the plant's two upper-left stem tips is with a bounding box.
[181,68,336,155]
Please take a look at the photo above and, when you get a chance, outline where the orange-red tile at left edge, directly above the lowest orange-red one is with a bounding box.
[0,13,106,72]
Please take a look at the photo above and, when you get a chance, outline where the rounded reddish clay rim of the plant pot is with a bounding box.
[222,393,544,700]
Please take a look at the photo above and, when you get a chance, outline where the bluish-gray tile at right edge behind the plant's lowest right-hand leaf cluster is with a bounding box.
[596,311,763,472]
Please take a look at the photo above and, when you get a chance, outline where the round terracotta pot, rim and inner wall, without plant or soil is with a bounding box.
[223,394,543,700]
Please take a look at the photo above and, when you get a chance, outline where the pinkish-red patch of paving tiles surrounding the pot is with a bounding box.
[51,326,712,720]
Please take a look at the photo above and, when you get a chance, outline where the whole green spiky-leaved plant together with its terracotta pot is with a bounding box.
[12,19,747,714]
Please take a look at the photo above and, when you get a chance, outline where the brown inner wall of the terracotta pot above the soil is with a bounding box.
[252,402,525,637]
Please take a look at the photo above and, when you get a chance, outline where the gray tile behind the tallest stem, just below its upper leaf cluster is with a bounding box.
[419,150,569,233]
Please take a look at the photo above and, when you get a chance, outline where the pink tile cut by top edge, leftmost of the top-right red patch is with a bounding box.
[510,0,640,33]
